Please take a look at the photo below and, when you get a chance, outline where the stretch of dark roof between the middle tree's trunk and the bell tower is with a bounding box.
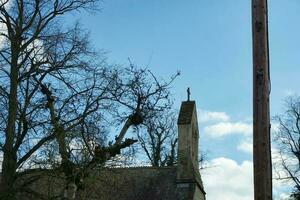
[86,167,176,200]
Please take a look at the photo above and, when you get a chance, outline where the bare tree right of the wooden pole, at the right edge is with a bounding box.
[273,96,300,199]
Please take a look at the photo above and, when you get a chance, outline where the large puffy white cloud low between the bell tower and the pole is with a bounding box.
[202,157,253,200]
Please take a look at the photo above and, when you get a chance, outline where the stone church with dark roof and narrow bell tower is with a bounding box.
[21,101,205,200]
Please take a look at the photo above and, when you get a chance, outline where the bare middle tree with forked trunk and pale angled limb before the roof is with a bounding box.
[30,66,175,199]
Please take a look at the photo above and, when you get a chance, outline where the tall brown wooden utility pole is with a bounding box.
[252,0,272,200]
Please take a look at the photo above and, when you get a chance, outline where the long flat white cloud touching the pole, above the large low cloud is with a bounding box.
[204,122,252,137]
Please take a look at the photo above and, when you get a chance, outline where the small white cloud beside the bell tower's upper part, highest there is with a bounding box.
[198,110,230,122]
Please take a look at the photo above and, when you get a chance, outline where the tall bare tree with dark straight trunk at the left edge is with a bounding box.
[0,0,102,199]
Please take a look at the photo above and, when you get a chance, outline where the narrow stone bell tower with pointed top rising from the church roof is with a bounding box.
[177,101,205,200]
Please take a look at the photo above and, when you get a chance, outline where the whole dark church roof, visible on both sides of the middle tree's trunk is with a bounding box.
[19,166,193,200]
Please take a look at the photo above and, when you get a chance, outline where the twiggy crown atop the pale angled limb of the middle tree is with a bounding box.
[106,64,180,143]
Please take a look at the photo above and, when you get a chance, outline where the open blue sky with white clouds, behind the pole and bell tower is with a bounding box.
[66,0,300,200]
